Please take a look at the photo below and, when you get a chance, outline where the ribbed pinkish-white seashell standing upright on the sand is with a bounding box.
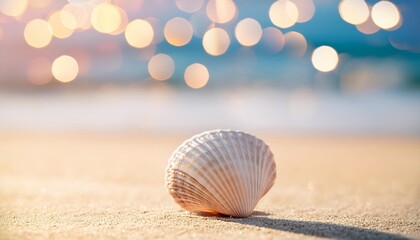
[165,130,276,217]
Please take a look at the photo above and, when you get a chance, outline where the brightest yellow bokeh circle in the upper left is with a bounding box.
[91,2,121,33]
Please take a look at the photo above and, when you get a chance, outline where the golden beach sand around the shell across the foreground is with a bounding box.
[0,133,420,239]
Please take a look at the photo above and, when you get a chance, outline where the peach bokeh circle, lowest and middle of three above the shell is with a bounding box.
[203,28,230,56]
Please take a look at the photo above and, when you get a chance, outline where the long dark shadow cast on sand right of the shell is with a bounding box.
[218,212,410,240]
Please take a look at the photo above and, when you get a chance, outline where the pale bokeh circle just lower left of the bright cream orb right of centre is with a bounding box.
[235,18,262,47]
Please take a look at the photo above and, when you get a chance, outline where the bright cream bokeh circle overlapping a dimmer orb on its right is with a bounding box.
[269,0,299,28]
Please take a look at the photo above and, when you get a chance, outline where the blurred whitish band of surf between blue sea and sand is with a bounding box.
[0,84,420,137]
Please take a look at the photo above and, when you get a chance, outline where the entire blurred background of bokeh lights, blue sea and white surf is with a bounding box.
[0,0,420,136]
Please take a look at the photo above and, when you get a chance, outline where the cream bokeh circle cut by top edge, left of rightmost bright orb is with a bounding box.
[338,0,369,25]
